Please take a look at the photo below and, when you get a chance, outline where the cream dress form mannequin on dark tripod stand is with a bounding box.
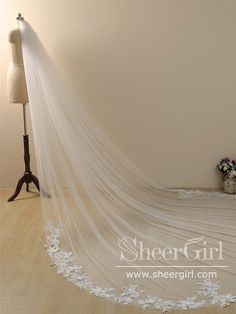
[7,13,40,202]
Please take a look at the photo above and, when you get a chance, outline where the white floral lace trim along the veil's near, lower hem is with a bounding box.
[47,221,236,312]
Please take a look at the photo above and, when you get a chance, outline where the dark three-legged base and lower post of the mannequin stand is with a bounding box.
[8,135,50,202]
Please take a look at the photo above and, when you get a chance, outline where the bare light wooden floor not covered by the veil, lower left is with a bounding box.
[0,189,236,314]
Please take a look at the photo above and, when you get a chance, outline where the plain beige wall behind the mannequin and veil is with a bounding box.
[0,0,236,187]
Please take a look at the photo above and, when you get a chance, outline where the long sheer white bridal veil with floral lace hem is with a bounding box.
[19,21,236,311]
